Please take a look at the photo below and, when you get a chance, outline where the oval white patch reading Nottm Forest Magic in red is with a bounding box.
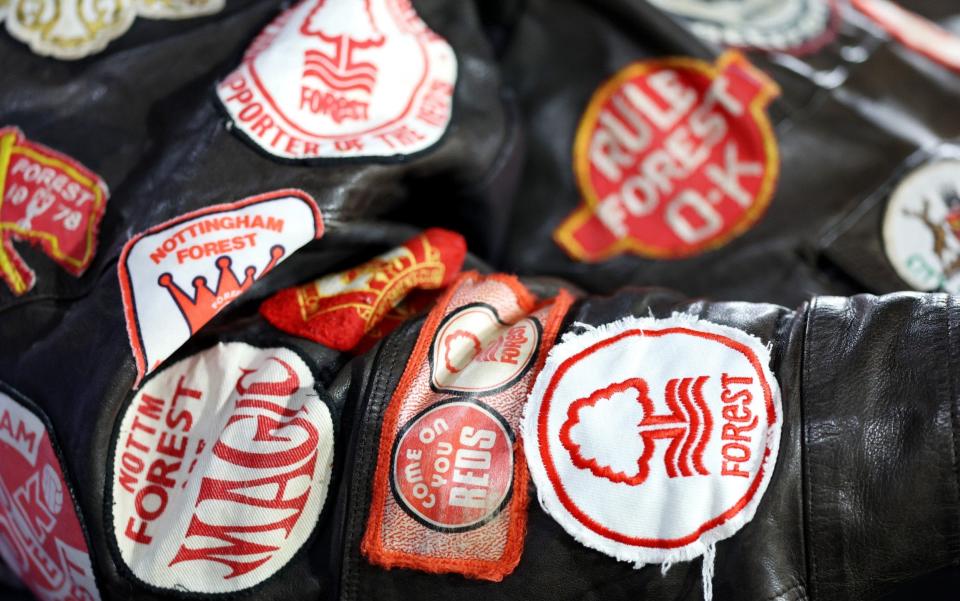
[108,342,334,593]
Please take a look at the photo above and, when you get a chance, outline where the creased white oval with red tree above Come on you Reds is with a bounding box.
[430,303,541,395]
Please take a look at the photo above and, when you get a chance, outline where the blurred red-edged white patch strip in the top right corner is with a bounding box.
[851,0,960,71]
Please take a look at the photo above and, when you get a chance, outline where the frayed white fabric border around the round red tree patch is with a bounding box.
[520,313,783,568]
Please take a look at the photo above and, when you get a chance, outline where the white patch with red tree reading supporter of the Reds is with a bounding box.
[217,0,457,159]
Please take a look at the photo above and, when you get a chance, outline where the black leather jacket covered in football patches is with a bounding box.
[0,0,960,601]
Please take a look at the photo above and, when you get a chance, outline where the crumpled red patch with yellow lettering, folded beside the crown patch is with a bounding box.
[260,228,467,351]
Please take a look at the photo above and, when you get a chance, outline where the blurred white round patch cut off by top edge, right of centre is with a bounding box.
[651,0,837,53]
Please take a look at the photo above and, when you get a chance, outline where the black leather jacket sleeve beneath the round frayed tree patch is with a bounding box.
[332,289,960,601]
